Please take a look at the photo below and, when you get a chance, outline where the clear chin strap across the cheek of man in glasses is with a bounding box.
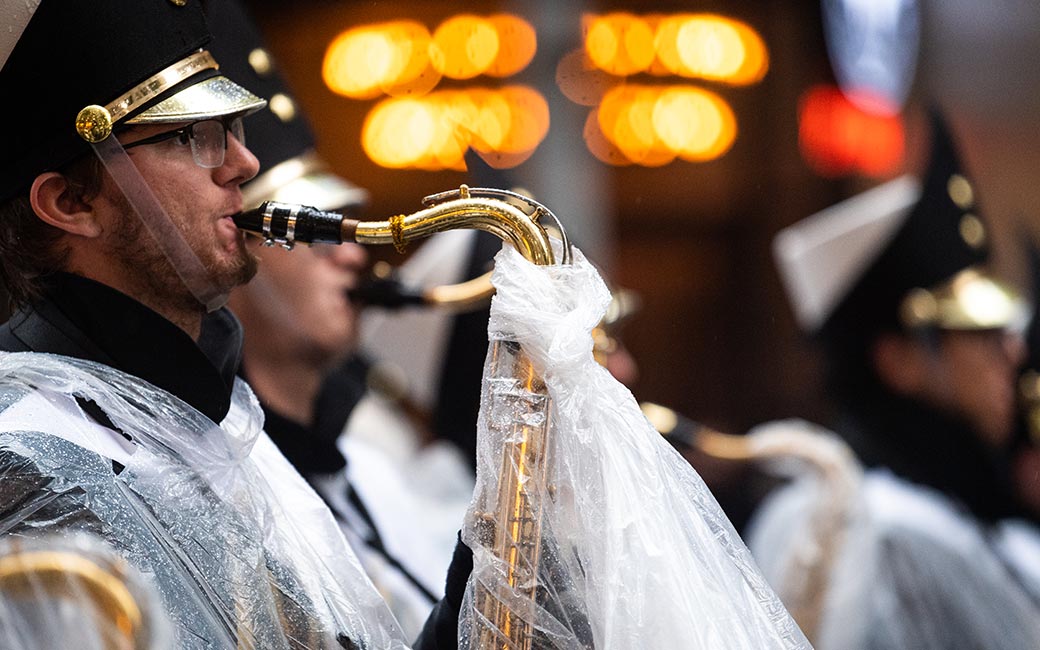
[90,135,228,312]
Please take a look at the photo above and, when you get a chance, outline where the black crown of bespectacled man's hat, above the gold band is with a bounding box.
[0,0,209,201]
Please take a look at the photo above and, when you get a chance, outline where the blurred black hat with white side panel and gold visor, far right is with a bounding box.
[774,111,1024,342]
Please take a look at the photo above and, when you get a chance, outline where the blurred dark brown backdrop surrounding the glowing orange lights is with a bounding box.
[239,0,1040,432]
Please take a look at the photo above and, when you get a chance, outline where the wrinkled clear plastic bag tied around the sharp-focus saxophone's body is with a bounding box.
[460,248,809,650]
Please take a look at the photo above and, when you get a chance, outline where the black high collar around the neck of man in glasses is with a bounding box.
[3,274,242,422]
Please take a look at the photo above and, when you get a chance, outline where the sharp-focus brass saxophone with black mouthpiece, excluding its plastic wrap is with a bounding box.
[234,185,571,650]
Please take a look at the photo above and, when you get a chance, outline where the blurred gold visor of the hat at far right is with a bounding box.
[900,267,1029,331]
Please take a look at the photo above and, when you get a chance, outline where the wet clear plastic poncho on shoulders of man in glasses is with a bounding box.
[0,353,407,650]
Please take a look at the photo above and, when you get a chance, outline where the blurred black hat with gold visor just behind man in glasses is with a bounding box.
[204,0,368,211]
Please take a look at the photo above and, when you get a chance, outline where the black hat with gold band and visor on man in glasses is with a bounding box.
[0,0,264,201]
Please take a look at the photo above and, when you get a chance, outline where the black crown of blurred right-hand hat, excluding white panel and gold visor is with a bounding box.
[820,111,989,339]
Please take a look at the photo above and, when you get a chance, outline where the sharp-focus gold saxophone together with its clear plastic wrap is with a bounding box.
[235,186,809,650]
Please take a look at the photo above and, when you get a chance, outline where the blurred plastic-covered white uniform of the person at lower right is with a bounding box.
[747,418,1040,650]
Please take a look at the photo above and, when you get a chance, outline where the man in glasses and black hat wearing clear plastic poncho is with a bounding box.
[0,0,457,649]
